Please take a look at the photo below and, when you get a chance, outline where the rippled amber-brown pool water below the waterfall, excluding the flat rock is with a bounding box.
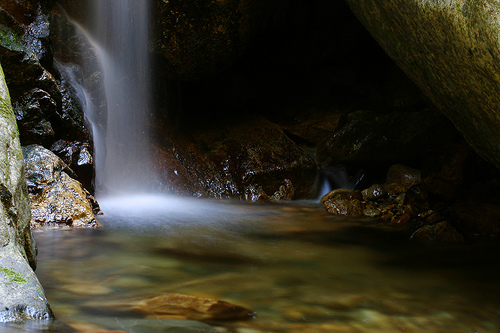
[6,197,500,333]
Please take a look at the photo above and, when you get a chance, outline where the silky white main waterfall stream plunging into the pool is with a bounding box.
[91,0,156,195]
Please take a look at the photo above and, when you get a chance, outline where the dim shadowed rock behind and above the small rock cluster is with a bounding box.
[316,109,455,164]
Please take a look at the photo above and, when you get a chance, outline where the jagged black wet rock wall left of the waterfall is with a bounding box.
[0,1,94,192]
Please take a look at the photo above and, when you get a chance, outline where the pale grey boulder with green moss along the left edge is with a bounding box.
[0,63,53,322]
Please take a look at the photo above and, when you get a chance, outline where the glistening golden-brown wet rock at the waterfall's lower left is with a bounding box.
[23,145,97,228]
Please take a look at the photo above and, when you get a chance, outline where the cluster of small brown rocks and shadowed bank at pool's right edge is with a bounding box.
[321,150,500,242]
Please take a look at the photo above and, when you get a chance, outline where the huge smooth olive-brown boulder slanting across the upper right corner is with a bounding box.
[347,0,500,167]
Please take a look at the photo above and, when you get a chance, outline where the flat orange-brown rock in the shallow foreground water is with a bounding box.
[132,293,253,321]
